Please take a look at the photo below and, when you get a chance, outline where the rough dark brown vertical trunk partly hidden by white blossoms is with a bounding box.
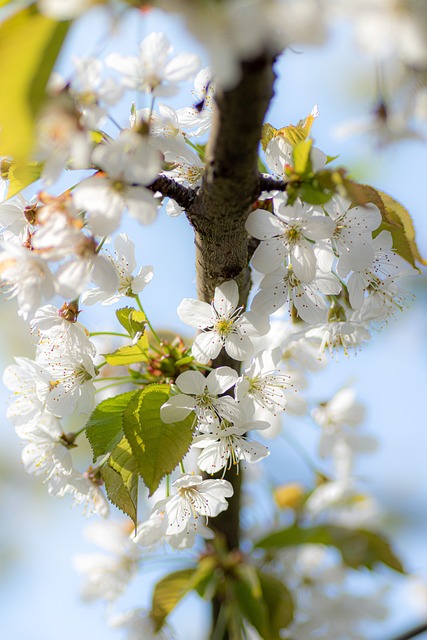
[187,55,275,640]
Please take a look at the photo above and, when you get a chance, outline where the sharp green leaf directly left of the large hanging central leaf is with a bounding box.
[86,391,136,461]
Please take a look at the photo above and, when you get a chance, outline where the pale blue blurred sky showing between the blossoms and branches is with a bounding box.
[0,9,427,640]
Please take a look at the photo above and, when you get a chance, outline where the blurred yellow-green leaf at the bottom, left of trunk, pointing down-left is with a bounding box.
[151,568,197,631]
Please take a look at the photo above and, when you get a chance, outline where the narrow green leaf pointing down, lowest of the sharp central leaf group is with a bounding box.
[108,438,138,527]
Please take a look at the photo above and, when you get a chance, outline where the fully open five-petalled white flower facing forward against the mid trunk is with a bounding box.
[178,280,269,364]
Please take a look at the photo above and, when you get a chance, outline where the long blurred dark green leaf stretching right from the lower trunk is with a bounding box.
[255,525,404,573]
